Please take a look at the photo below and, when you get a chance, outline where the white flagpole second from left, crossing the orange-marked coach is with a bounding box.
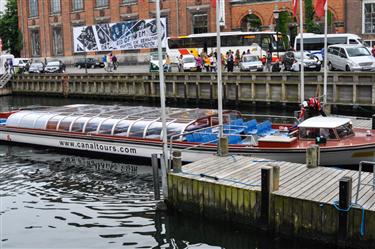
[216,0,223,137]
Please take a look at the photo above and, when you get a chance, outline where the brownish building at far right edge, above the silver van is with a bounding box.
[346,0,375,47]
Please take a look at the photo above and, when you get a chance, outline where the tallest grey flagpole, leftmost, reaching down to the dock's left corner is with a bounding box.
[155,0,168,198]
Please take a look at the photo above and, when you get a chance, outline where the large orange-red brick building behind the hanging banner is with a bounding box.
[18,0,346,58]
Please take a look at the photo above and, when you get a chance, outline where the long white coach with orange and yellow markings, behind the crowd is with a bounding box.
[166,31,290,63]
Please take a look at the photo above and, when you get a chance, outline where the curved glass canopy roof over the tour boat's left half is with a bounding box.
[6,104,237,139]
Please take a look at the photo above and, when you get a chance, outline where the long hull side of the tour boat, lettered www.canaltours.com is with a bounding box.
[0,131,375,166]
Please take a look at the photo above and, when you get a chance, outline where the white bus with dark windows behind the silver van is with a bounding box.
[294,33,362,61]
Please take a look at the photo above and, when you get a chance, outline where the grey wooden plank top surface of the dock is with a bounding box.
[173,156,375,211]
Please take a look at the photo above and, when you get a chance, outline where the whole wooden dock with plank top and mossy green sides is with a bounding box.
[168,156,375,248]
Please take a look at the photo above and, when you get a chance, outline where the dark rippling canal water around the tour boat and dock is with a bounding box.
[0,97,358,249]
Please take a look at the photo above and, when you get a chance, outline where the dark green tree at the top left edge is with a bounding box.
[0,0,23,57]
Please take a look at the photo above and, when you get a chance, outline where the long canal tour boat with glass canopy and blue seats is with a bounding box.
[0,104,375,166]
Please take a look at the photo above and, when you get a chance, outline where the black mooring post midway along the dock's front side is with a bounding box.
[260,167,273,226]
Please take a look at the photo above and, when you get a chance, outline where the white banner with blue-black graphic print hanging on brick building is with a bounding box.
[73,18,167,53]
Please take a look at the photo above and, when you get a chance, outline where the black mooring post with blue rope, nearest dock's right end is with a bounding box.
[337,176,352,243]
